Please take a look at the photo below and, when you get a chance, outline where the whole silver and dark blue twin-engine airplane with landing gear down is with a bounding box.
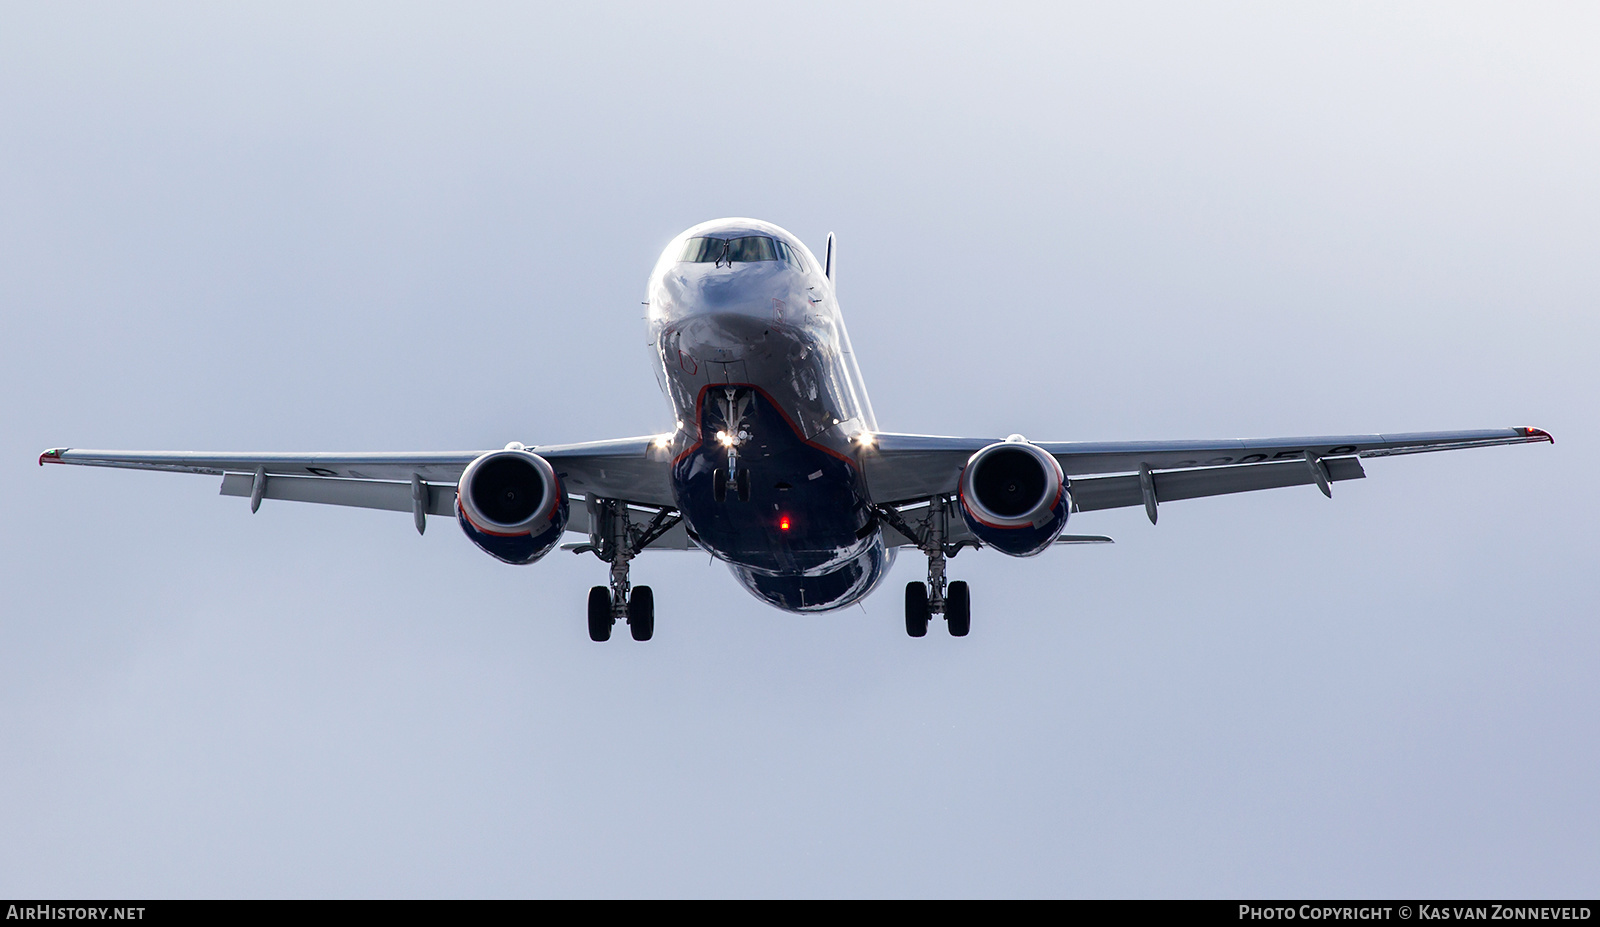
[38,218,1554,640]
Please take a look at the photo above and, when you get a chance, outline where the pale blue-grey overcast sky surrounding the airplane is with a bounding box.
[0,3,1600,897]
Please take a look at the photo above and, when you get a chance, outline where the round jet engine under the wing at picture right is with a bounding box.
[958,434,1070,557]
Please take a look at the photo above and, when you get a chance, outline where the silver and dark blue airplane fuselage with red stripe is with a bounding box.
[648,219,893,612]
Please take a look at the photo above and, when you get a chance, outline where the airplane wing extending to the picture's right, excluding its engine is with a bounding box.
[861,427,1554,511]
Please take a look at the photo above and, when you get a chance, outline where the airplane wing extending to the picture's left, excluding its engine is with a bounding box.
[38,437,675,532]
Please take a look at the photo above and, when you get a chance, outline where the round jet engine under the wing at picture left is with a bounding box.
[456,445,568,564]
